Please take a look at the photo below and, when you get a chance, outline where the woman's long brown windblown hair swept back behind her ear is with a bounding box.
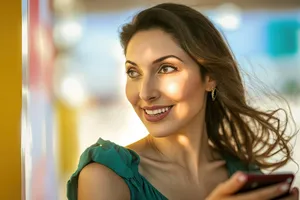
[120,3,298,169]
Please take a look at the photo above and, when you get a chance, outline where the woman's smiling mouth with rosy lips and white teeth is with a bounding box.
[143,106,173,122]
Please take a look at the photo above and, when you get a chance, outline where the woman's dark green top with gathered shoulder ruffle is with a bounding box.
[67,138,260,200]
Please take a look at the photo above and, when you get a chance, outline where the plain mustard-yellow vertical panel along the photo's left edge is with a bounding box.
[0,0,22,200]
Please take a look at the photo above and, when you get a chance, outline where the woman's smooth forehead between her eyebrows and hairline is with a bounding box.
[126,29,186,62]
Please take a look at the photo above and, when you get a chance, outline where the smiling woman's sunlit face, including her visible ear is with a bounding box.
[126,29,215,137]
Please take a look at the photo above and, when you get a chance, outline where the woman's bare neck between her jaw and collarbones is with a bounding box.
[149,112,219,177]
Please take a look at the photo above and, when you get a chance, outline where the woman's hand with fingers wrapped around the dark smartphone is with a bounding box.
[206,172,299,200]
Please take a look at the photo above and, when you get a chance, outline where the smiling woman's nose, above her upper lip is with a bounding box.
[139,78,160,102]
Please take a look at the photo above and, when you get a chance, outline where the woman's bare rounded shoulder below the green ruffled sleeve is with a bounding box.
[78,163,130,200]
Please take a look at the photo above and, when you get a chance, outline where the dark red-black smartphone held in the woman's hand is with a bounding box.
[237,173,295,200]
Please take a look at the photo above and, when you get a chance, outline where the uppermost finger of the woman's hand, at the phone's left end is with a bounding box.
[210,172,247,199]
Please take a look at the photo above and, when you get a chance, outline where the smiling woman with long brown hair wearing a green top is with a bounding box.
[68,4,298,200]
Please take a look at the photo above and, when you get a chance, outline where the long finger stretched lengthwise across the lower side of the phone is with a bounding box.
[236,183,289,200]
